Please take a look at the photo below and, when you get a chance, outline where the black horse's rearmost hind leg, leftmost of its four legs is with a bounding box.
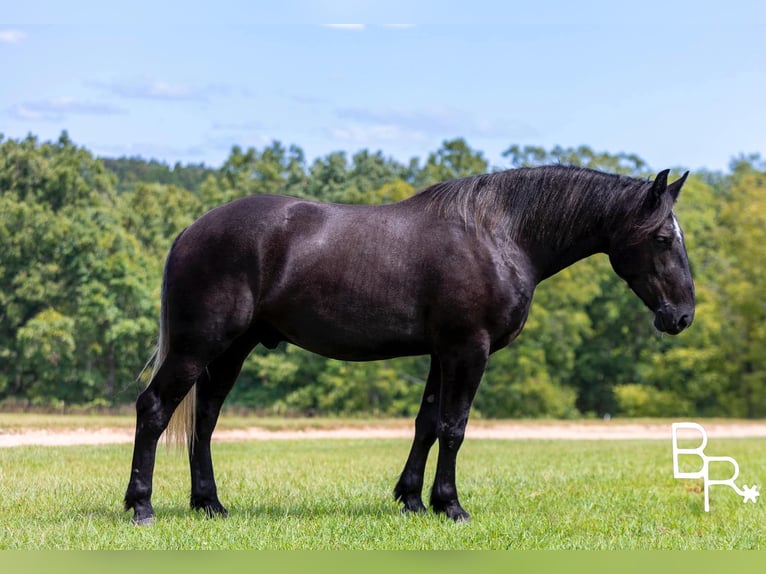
[125,352,210,524]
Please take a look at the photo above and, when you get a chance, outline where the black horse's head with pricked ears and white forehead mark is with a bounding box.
[609,170,694,335]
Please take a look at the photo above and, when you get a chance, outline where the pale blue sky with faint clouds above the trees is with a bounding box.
[0,0,766,170]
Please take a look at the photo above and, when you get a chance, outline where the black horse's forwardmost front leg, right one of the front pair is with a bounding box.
[431,342,489,522]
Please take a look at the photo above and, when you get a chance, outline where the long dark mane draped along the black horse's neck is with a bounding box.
[412,165,673,248]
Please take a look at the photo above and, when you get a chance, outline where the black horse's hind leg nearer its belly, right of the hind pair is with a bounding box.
[189,333,257,517]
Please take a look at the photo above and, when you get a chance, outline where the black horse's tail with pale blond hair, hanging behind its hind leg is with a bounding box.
[147,232,197,449]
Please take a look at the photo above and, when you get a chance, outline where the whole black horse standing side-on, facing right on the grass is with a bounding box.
[125,166,694,524]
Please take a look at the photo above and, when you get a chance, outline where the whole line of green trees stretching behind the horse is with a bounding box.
[0,132,766,417]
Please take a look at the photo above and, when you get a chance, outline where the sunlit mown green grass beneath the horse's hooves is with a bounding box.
[0,439,766,549]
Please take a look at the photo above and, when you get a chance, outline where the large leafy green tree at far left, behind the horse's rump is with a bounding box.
[0,134,159,402]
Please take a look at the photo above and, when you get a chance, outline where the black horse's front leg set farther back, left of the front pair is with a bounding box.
[394,357,441,512]
